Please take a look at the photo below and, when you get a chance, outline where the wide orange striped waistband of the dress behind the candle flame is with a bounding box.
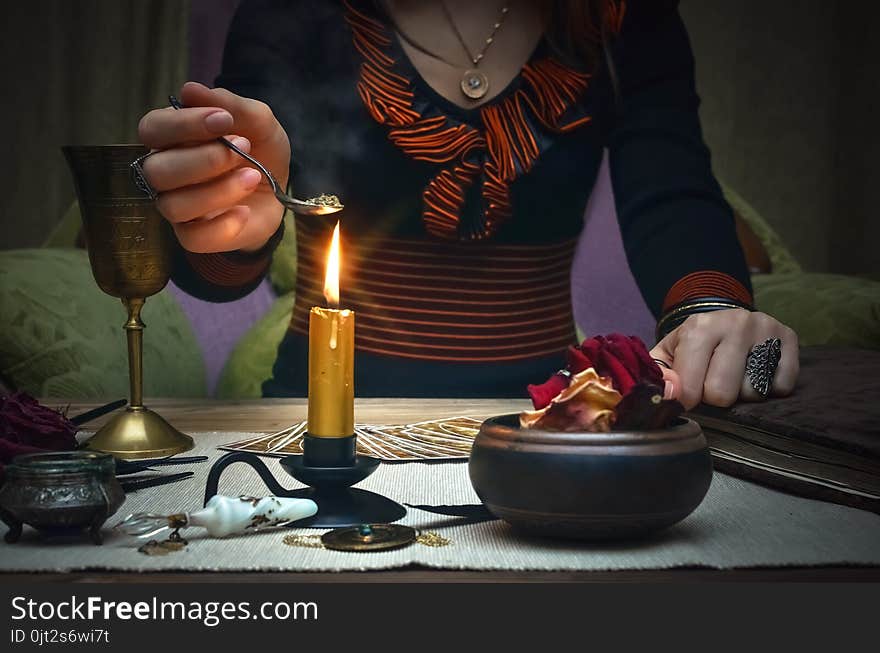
[290,221,576,362]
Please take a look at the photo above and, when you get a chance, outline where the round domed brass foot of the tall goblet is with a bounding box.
[85,406,194,460]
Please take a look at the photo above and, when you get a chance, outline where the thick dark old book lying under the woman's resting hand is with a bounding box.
[690,347,880,514]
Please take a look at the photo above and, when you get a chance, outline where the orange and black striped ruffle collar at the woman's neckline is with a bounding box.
[344,0,622,240]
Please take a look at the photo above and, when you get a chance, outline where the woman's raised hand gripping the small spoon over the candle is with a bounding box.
[138,82,290,253]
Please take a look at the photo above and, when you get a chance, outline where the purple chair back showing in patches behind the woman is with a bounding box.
[179,0,655,394]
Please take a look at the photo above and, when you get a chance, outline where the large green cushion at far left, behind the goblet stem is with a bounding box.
[0,249,206,399]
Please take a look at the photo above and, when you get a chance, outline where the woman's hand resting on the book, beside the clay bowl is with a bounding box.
[651,309,800,410]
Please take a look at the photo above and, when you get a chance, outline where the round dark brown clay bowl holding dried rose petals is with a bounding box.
[469,415,712,540]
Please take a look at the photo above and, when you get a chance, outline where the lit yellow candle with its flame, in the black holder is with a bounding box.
[308,222,354,438]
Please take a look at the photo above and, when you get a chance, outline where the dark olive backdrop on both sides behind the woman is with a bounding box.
[0,0,880,277]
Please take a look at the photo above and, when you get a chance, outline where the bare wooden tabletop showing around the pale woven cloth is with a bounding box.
[0,399,880,583]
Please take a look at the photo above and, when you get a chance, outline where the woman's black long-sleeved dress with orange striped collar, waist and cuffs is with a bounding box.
[175,0,751,397]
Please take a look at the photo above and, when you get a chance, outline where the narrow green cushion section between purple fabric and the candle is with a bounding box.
[216,293,295,399]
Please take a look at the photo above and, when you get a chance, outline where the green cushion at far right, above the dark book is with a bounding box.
[752,273,880,349]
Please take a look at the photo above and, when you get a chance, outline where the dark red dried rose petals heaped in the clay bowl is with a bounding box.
[528,333,663,410]
